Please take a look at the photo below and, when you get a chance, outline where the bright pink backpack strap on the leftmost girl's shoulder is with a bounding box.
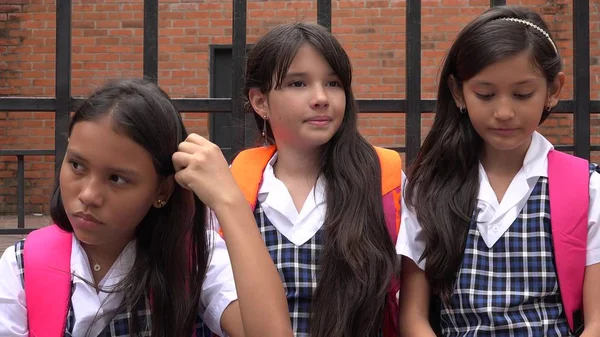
[23,225,73,337]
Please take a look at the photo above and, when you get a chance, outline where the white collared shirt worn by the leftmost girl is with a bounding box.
[0,231,237,337]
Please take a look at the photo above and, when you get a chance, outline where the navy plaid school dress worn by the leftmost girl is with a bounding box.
[15,239,214,337]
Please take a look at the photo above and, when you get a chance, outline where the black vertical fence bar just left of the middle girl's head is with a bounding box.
[231,0,246,153]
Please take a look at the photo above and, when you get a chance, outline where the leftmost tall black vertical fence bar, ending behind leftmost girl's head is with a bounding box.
[54,0,71,173]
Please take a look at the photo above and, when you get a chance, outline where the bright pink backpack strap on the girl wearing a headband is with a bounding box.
[548,150,589,332]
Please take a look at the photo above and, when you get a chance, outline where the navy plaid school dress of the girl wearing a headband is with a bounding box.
[440,165,597,337]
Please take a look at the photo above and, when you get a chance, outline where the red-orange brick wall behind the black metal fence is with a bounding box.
[0,0,600,214]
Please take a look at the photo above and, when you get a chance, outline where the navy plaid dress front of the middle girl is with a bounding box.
[254,202,323,337]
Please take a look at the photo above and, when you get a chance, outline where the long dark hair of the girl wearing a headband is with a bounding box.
[405,6,562,302]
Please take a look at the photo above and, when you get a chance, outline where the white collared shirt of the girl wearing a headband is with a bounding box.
[396,132,600,270]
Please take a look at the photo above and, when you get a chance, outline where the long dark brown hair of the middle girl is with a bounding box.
[244,23,397,337]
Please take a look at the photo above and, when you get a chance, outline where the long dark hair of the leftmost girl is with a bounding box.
[51,80,208,337]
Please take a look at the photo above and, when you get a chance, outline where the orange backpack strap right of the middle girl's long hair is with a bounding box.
[375,147,402,337]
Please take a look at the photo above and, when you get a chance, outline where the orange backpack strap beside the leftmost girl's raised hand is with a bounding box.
[231,146,277,210]
